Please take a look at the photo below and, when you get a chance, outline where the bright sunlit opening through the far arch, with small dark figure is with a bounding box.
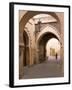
[46,38,61,62]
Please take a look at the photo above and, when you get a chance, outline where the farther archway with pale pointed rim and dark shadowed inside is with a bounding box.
[36,25,61,63]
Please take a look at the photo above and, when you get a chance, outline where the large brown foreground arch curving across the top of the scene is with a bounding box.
[19,11,61,46]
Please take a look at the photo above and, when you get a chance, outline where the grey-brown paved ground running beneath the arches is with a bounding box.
[23,61,64,79]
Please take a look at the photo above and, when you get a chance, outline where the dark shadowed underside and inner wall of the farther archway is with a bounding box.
[38,32,59,62]
